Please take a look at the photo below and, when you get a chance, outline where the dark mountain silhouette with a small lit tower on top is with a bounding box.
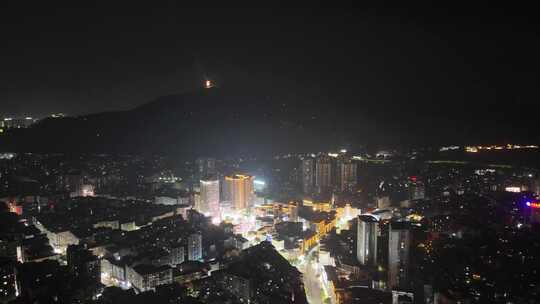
[0,88,376,155]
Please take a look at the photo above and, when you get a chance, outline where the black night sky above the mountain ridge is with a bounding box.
[0,1,540,141]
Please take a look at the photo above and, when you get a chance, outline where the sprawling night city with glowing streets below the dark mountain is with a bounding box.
[0,150,540,303]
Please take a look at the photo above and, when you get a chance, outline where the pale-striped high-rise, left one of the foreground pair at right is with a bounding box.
[356,215,379,266]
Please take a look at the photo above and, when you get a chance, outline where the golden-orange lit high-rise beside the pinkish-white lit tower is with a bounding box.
[224,174,253,210]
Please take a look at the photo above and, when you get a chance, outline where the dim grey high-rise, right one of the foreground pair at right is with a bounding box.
[388,222,411,289]
